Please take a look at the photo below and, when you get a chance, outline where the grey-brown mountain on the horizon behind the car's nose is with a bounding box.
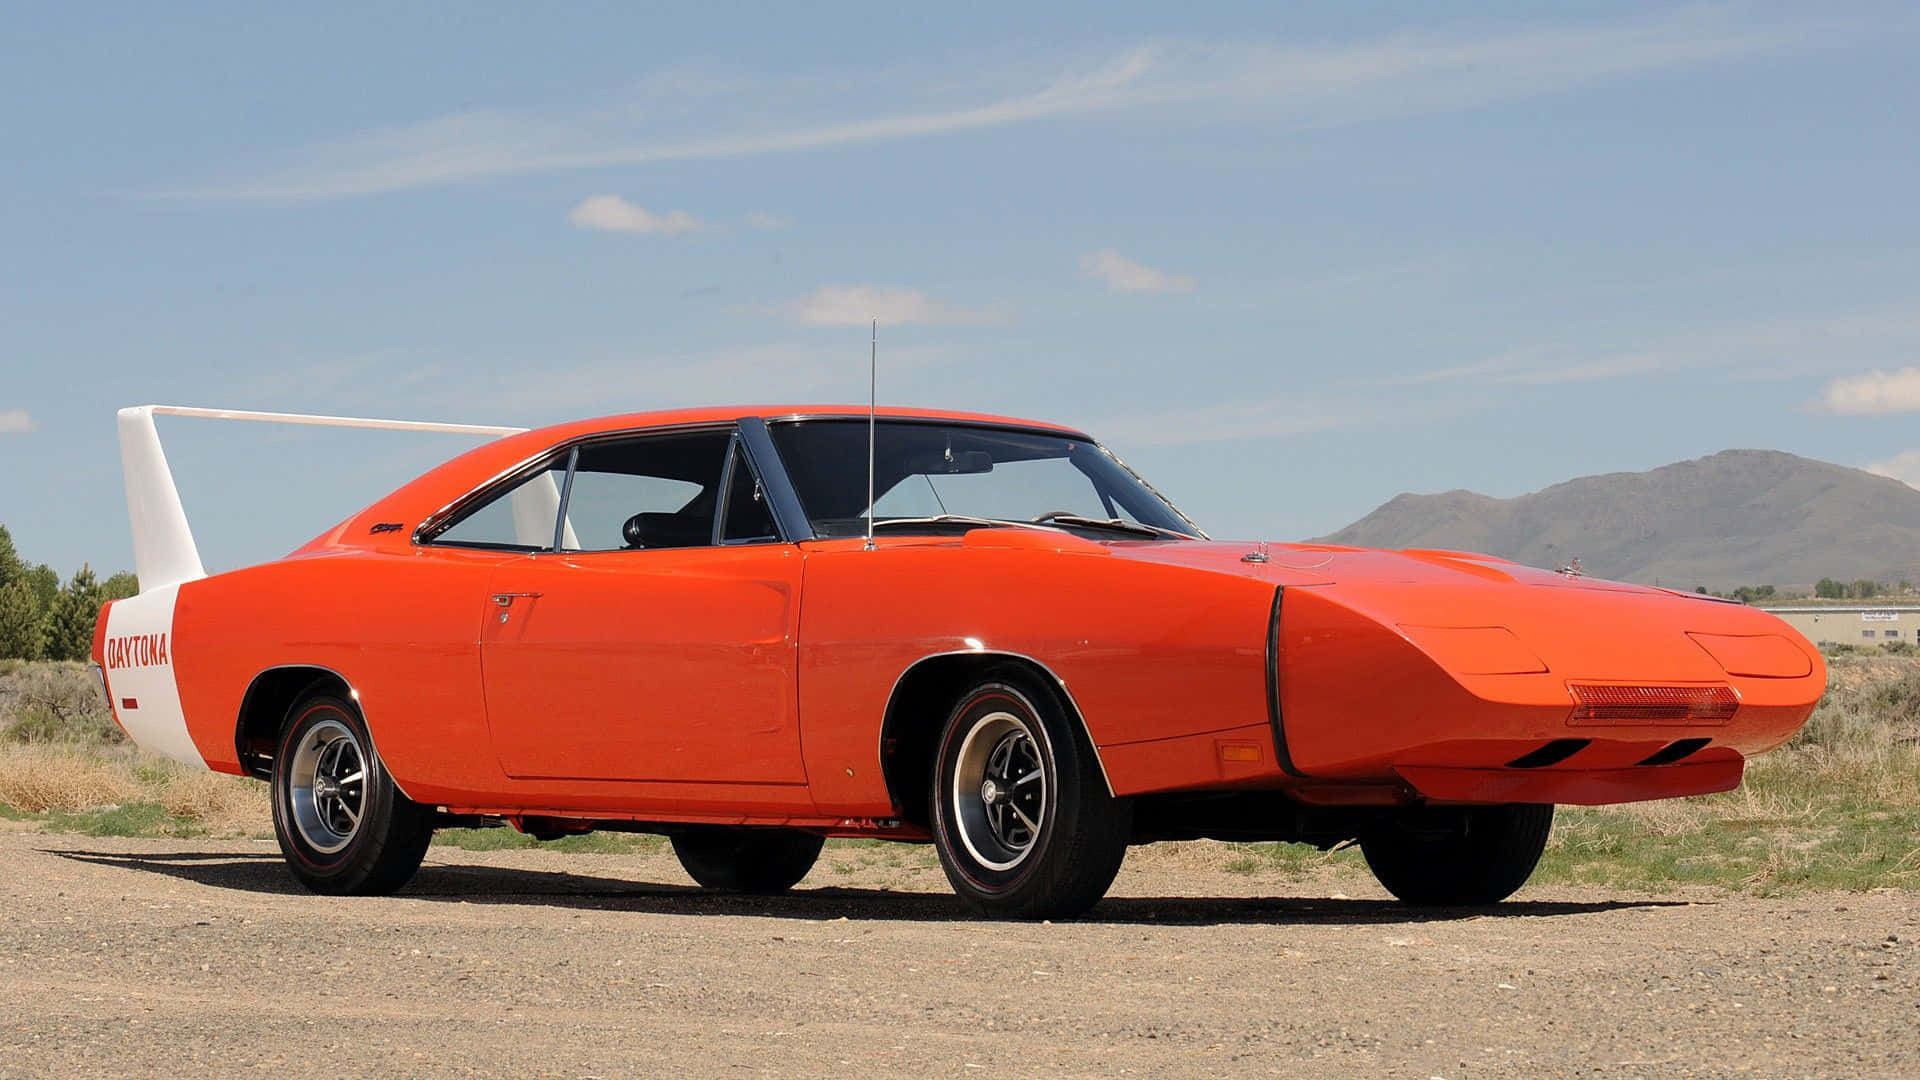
[1319,450,1920,590]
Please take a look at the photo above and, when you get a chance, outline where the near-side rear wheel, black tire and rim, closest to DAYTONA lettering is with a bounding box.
[273,694,434,896]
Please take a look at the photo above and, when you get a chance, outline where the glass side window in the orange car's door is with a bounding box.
[563,430,732,552]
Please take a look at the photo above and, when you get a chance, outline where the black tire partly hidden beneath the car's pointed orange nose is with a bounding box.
[1359,803,1553,907]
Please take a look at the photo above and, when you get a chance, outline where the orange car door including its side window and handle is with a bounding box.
[480,429,806,784]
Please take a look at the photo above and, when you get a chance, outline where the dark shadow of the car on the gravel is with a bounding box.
[33,849,1690,926]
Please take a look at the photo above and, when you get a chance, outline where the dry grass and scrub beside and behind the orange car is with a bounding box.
[0,651,1920,894]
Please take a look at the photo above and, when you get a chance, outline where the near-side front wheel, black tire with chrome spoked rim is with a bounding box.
[929,669,1133,919]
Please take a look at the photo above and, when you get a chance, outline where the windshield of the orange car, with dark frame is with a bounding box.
[770,419,1196,538]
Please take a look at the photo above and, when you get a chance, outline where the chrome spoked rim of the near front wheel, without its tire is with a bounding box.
[948,713,1050,871]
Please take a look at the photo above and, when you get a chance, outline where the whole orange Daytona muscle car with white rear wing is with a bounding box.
[94,405,1826,917]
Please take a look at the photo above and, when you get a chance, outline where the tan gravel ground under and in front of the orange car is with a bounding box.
[0,830,1920,1078]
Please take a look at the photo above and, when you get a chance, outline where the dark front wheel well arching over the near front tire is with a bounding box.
[879,651,1112,826]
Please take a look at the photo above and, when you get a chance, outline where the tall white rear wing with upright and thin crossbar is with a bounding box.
[119,405,526,592]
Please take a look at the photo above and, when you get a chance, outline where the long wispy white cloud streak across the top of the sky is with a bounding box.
[150,8,1830,202]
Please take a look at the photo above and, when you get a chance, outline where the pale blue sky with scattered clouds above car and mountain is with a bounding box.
[0,2,1920,573]
